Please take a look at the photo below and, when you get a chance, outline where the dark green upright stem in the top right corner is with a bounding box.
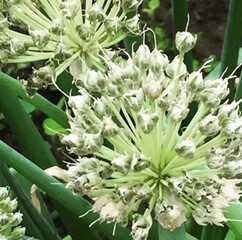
[220,0,242,101]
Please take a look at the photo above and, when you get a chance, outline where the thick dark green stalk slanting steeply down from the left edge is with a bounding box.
[0,78,56,169]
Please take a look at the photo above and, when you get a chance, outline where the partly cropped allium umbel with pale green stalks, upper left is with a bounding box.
[0,0,142,95]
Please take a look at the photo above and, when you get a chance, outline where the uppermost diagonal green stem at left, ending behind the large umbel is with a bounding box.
[0,71,69,128]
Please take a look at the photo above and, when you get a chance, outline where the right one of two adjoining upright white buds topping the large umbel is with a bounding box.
[150,48,169,75]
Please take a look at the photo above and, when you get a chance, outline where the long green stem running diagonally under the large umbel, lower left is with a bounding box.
[0,141,131,240]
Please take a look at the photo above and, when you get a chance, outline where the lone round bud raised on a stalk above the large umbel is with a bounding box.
[175,32,197,53]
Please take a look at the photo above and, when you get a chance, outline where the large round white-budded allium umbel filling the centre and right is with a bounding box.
[63,33,242,240]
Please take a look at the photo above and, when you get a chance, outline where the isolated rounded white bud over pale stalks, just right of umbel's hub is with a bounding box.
[175,140,196,158]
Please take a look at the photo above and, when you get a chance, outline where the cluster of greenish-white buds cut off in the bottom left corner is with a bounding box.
[0,187,25,240]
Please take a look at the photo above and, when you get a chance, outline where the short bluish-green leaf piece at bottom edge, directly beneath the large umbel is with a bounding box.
[158,224,186,240]
